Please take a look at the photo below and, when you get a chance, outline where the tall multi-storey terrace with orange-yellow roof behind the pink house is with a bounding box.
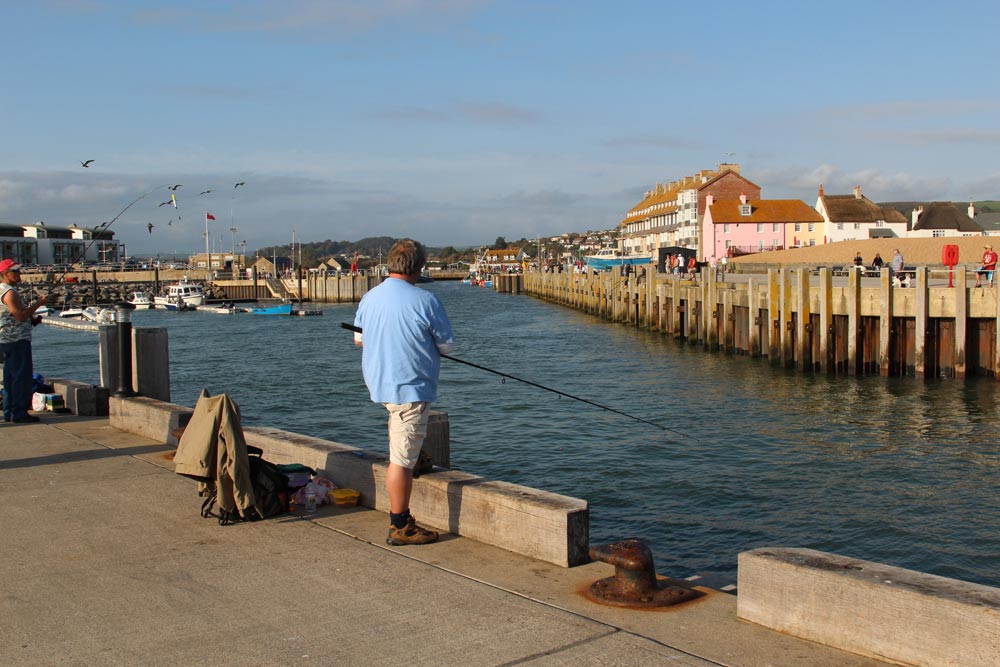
[618,163,760,260]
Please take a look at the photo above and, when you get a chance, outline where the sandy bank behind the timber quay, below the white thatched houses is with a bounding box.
[730,236,1000,268]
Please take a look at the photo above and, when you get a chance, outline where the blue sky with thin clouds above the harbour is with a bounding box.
[0,0,1000,255]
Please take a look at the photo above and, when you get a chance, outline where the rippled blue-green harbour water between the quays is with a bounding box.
[34,283,1000,586]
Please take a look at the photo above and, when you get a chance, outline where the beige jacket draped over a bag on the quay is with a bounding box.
[174,393,254,515]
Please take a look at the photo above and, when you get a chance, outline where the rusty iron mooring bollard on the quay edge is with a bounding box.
[587,538,704,609]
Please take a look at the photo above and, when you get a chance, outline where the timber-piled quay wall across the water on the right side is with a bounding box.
[524,267,1000,378]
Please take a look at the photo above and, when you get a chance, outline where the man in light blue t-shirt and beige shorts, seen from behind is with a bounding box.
[354,239,455,546]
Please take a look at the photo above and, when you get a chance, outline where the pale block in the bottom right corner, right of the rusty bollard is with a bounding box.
[737,548,1000,667]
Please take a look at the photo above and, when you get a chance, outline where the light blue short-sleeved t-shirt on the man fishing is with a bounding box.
[354,278,455,403]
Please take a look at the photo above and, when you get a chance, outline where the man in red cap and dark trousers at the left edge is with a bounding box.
[0,259,46,424]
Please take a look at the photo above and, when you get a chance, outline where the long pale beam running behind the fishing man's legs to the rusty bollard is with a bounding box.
[243,427,590,567]
